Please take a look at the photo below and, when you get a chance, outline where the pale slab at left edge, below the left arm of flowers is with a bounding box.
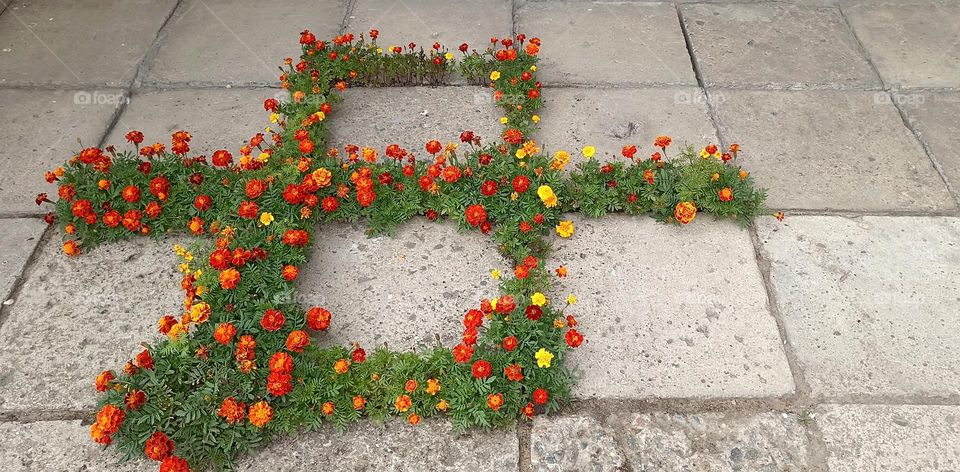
[0,235,183,411]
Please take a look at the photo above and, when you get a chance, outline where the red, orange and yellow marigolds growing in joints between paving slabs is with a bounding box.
[37,30,763,471]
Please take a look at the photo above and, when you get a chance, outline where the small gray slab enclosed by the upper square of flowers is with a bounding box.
[330,87,502,158]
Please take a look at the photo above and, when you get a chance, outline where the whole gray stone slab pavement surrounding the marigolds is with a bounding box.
[0,0,960,471]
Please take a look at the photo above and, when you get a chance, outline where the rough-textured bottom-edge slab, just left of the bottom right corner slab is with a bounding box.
[530,412,811,471]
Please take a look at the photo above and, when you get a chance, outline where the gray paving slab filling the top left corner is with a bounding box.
[0,0,177,86]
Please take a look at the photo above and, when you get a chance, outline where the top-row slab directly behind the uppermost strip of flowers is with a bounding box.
[347,0,513,57]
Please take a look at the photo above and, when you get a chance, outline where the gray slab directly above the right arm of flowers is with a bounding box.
[536,87,718,169]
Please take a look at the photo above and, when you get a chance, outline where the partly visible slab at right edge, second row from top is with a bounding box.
[893,91,960,195]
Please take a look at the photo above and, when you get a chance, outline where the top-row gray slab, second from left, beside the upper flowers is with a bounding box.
[149,0,346,85]
